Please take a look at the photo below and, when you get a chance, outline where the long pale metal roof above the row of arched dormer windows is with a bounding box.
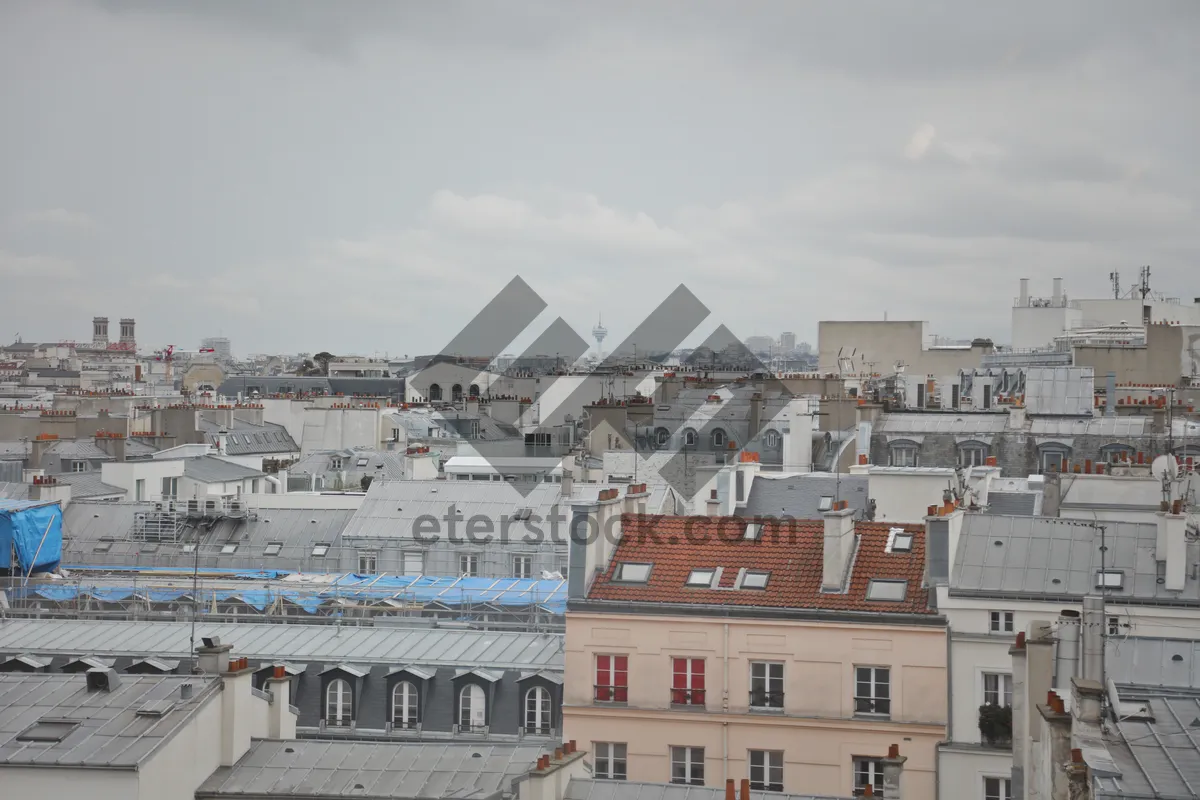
[0,619,563,669]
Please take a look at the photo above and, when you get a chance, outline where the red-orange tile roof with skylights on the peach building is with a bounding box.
[588,515,936,614]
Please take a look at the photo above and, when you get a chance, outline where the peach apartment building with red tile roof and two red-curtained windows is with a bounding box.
[563,510,947,798]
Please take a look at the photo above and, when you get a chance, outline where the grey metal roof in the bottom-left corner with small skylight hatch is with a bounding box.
[0,673,220,767]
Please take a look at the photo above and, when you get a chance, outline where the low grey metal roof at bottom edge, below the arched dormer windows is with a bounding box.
[196,740,546,800]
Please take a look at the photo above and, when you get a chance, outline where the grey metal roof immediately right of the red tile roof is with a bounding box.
[950,513,1200,606]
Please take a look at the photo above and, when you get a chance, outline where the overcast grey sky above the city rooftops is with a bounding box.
[0,0,1200,355]
